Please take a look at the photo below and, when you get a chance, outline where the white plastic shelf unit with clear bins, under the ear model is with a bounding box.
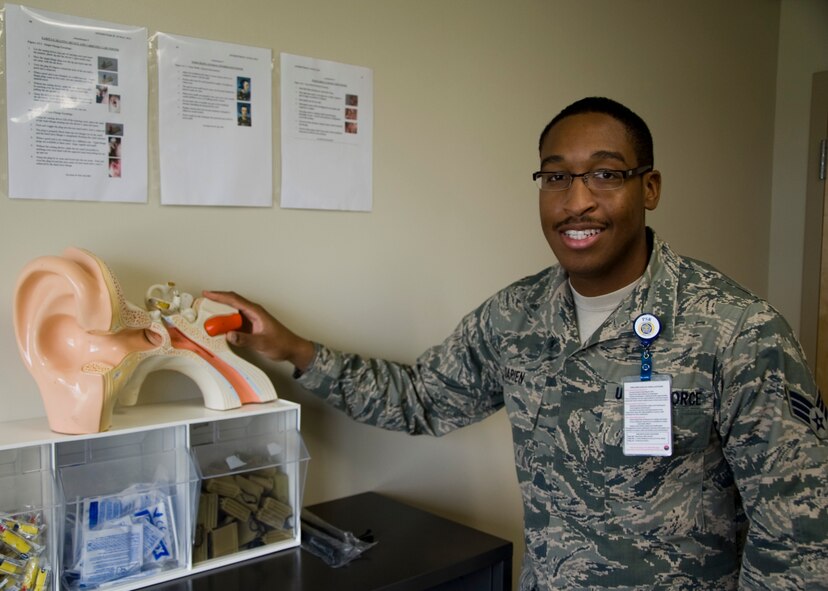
[0,400,310,591]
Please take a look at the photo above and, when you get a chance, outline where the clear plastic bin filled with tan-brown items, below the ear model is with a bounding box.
[190,412,309,566]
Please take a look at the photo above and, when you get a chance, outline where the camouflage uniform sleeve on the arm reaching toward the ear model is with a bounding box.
[298,302,503,435]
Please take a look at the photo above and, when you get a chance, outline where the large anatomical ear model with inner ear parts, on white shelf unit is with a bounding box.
[14,248,276,433]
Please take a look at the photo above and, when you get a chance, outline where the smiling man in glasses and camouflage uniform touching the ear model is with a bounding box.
[206,99,828,591]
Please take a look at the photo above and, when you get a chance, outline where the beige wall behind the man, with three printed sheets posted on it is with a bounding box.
[0,0,780,584]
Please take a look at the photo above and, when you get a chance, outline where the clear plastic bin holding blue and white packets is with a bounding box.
[56,426,198,590]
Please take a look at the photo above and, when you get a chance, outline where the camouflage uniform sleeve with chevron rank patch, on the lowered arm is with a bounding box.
[719,303,828,591]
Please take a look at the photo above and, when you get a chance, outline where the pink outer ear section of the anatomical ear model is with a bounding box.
[14,248,157,434]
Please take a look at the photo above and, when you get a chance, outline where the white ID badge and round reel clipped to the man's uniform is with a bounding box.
[624,314,673,456]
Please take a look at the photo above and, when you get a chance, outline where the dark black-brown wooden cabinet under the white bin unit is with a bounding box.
[146,493,512,591]
